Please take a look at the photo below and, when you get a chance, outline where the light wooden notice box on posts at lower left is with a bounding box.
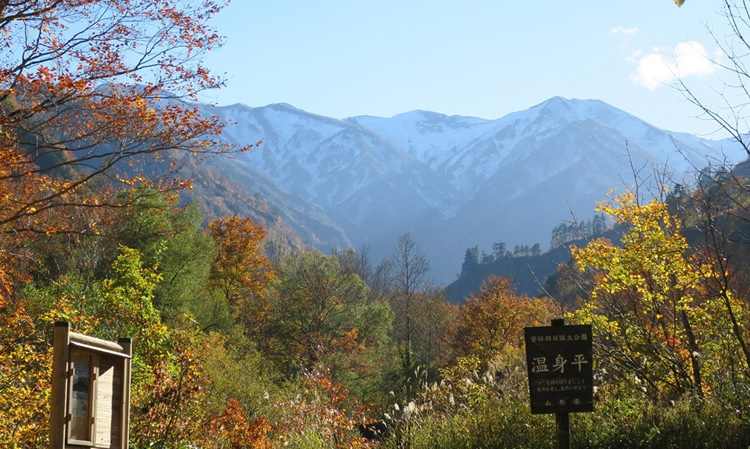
[50,323,132,449]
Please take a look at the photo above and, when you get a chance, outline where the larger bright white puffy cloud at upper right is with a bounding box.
[632,41,716,90]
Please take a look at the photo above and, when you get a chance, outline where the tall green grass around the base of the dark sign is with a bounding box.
[379,360,750,449]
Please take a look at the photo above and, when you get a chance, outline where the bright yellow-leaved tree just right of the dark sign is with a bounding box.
[572,191,737,398]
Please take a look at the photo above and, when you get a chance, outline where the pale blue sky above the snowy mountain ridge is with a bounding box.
[200,0,727,137]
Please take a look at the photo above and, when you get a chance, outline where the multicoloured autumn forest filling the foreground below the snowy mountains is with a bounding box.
[7,0,750,449]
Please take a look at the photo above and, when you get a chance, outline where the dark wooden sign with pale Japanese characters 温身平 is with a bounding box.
[524,325,594,414]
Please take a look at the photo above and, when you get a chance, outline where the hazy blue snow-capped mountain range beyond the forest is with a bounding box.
[191,97,743,284]
